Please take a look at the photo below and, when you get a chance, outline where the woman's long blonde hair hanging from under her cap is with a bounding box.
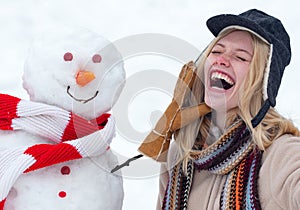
[172,29,300,169]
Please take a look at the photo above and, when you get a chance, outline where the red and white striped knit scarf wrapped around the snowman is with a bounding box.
[0,94,114,210]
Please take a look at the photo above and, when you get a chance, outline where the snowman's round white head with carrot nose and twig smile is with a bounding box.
[23,29,125,119]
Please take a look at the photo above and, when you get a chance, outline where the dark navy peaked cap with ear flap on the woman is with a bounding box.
[206,9,291,127]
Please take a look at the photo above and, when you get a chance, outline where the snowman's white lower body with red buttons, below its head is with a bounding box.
[0,131,123,210]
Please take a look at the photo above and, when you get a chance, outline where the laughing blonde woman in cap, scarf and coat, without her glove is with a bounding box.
[157,9,300,210]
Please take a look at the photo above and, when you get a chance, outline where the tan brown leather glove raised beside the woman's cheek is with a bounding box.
[138,61,210,161]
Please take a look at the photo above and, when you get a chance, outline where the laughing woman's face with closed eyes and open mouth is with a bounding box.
[204,31,253,111]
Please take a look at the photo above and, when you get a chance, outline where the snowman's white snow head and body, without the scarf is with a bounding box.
[0,28,125,210]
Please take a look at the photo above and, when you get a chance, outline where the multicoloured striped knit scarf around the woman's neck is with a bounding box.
[162,120,262,210]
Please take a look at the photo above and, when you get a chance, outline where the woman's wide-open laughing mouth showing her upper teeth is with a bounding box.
[210,71,235,90]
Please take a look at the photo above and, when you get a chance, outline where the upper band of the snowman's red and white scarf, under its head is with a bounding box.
[0,94,110,143]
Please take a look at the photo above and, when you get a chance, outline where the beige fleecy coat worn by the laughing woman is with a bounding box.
[157,135,300,210]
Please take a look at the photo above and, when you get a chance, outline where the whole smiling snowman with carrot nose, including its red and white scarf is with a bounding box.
[0,28,125,210]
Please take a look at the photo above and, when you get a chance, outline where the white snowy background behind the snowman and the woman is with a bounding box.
[0,0,300,210]
